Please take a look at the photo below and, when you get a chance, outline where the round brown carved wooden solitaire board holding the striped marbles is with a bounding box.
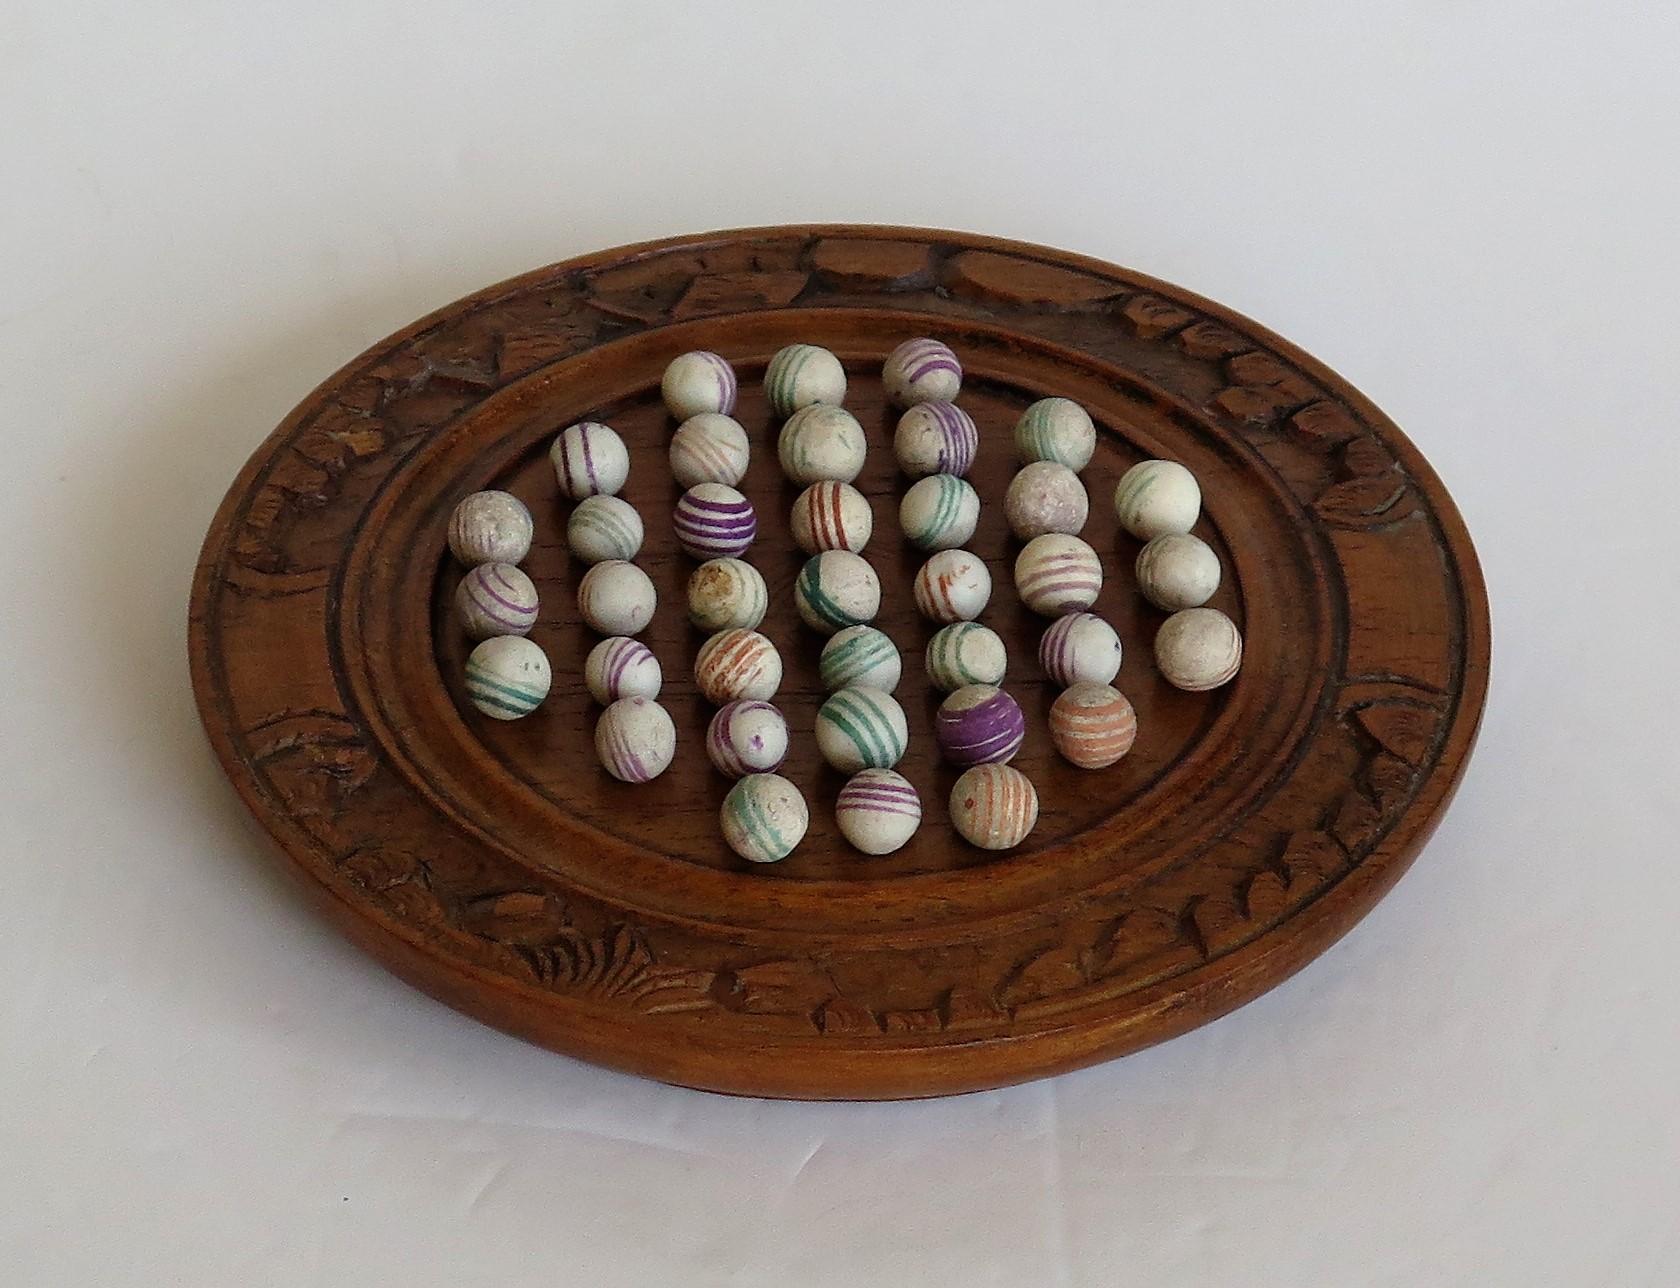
[192,227,1488,1098]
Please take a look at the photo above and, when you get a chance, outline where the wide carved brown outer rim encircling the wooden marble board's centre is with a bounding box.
[190,227,1488,1097]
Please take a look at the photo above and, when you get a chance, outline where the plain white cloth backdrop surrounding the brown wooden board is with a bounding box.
[0,0,1680,1288]
